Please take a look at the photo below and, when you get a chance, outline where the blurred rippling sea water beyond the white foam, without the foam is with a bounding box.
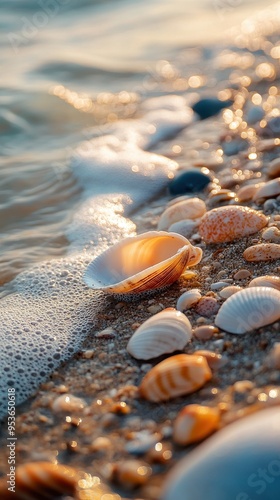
[0,0,280,283]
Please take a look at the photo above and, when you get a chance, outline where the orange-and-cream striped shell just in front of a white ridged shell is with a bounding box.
[139,354,212,402]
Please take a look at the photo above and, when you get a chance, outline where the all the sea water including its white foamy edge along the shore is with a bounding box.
[0,0,279,416]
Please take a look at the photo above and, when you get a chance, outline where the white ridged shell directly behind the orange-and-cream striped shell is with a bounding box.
[127,308,192,359]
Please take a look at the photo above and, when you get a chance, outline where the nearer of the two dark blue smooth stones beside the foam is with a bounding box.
[169,170,211,195]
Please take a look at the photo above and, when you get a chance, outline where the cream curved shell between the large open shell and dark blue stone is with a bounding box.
[158,198,206,231]
